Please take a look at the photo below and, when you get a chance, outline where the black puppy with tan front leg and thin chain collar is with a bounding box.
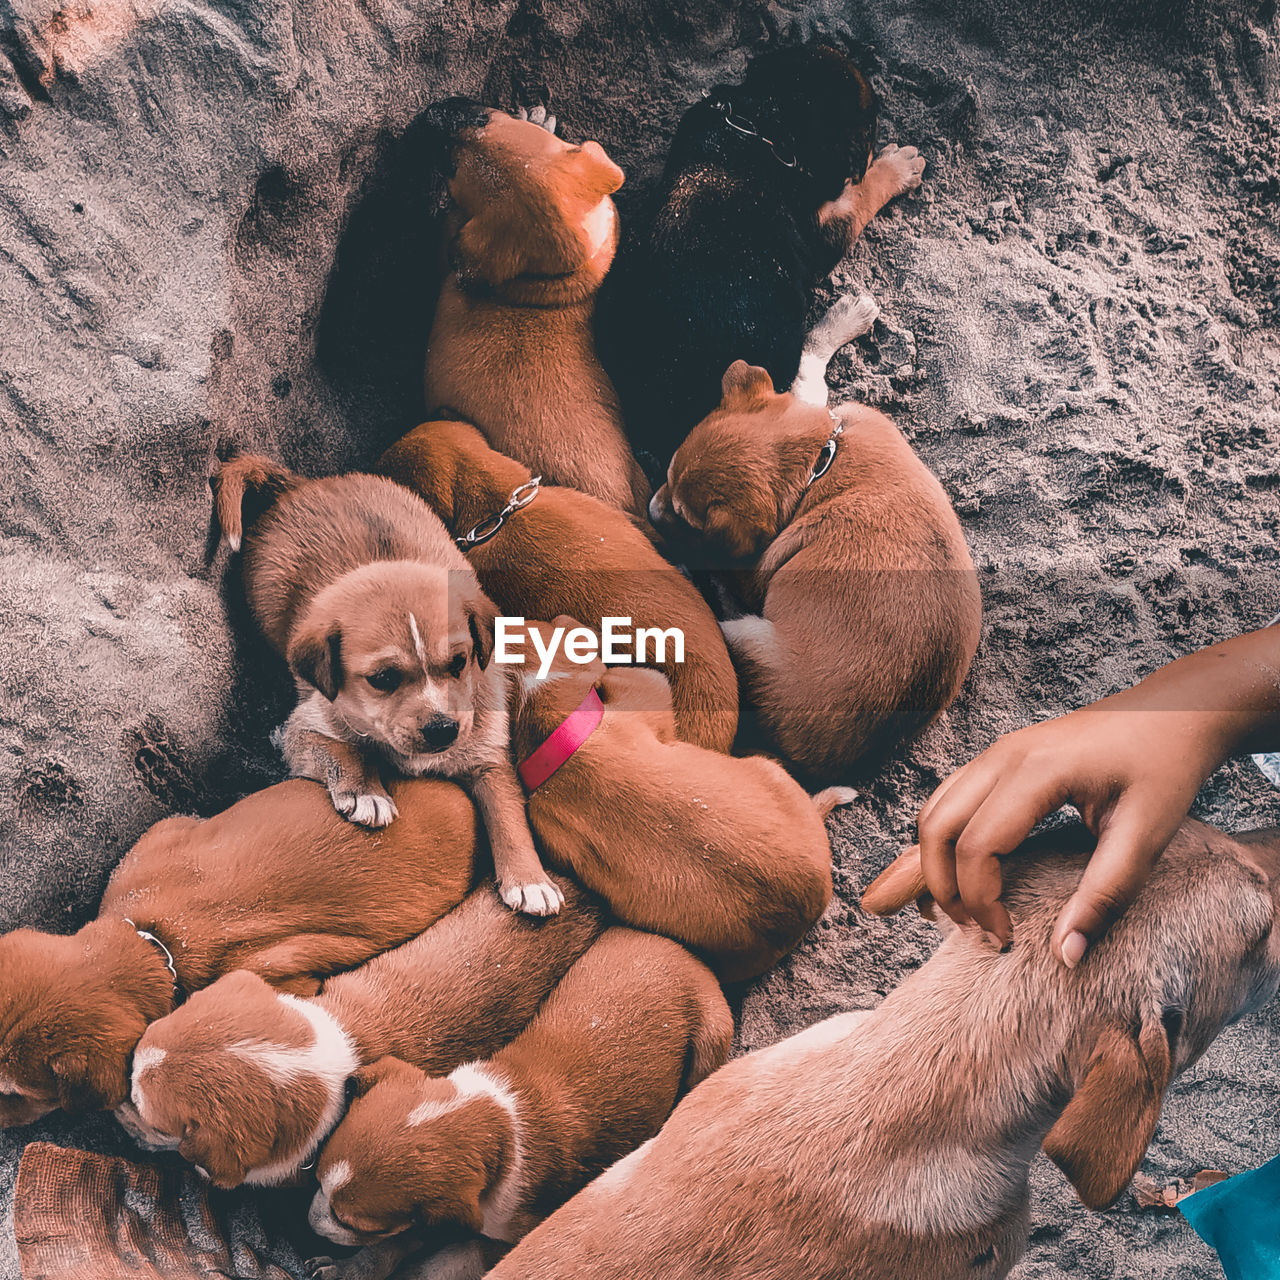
[603,45,924,461]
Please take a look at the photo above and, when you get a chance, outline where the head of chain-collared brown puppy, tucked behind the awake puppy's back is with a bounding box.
[376,421,530,535]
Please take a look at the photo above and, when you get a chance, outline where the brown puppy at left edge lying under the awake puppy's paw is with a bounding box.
[0,780,477,1125]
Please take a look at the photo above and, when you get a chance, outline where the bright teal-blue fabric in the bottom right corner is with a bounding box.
[1178,1156,1280,1280]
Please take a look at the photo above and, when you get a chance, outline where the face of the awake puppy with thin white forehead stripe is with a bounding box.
[288,561,497,774]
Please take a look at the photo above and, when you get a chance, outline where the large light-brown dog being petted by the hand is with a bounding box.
[492,822,1280,1280]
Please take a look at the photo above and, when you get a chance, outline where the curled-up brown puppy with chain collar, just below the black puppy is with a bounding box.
[650,361,982,778]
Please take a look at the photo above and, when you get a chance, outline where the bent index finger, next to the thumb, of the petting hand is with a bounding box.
[955,768,1068,946]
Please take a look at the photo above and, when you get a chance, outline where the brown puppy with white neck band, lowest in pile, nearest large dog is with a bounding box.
[308,928,733,1280]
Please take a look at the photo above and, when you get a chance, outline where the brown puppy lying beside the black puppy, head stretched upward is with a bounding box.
[426,99,649,518]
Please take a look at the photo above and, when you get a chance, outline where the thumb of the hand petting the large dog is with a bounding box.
[1052,791,1180,969]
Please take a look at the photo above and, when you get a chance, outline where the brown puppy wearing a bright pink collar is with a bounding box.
[512,618,852,982]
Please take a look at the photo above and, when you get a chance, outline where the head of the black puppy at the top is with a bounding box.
[728,45,879,200]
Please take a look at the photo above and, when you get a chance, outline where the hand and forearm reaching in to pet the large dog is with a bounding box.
[919,627,1280,968]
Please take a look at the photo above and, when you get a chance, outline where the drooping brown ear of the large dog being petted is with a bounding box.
[1044,1010,1181,1208]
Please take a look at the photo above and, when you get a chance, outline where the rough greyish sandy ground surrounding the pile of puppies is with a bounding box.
[0,0,1280,1280]
